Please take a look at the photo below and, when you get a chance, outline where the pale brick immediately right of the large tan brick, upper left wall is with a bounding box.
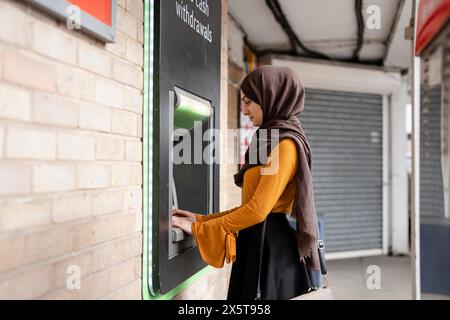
[56,65,95,101]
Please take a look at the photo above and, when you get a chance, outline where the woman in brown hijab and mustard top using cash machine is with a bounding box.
[173,66,320,300]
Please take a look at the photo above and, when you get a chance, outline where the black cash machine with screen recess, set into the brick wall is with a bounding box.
[149,0,222,294]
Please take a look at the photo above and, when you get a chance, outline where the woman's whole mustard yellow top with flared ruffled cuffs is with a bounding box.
[192,139,298,268]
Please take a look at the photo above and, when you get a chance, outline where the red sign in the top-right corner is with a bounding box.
[416,0,450,55]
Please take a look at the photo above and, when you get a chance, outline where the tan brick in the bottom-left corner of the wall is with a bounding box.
[0,266,53,300]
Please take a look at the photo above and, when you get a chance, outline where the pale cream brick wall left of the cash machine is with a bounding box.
[0,0,143,299]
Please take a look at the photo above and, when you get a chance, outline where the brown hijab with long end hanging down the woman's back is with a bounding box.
[234,66,320,271]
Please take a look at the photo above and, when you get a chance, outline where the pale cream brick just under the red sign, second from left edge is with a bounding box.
[33,22,78,65]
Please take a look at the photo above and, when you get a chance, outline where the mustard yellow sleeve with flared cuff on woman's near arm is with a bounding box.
[192,139,297,268]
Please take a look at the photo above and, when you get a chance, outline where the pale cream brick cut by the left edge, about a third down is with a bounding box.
[0,82,30,121]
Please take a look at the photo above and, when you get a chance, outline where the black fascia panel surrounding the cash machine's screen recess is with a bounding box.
[150,0,222,294]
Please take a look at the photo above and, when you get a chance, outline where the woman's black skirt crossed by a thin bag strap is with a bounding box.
[227,213,310,300]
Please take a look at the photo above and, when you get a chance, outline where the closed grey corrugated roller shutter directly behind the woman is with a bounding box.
[300,89,383,252]
